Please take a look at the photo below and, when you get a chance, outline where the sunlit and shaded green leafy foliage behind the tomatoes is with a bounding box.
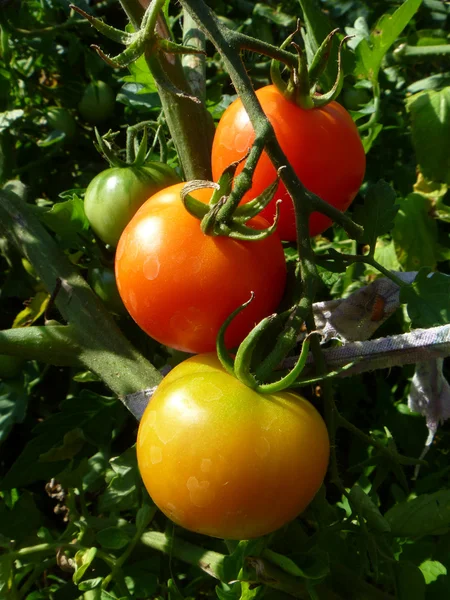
[0,0,450,600]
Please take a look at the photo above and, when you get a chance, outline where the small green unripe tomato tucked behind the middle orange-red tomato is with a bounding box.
[84,162,181,247]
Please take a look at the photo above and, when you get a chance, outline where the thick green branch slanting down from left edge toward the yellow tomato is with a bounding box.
[0,191,161,397]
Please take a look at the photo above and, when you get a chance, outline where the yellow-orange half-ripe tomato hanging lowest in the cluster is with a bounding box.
[136,354,329,539]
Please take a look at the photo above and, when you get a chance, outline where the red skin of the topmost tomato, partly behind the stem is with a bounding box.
[212,85,366,241]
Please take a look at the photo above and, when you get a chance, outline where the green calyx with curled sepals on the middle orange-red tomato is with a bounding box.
[181,162,279,241]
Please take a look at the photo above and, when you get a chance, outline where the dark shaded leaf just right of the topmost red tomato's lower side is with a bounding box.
[354,179,398,248]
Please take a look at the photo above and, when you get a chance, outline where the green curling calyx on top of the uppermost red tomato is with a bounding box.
[270,23,352,110]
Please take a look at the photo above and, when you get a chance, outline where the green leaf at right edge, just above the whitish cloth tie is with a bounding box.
[400,268,450,328]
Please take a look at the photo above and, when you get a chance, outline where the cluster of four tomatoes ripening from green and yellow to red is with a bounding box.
[85,86,365,539]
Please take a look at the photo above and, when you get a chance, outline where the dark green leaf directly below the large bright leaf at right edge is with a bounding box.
[392,194,438,271]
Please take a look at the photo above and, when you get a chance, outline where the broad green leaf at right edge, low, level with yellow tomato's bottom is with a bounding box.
[384,490,450,537]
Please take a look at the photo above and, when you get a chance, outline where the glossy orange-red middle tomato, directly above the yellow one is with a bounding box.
[116,184,286,353]
